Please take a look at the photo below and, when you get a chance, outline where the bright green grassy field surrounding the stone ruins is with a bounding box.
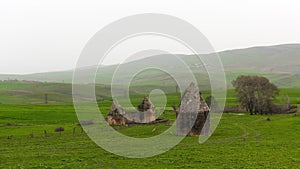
[0,81,300,169]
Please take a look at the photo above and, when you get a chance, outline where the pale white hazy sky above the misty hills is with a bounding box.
[0,0,300,74]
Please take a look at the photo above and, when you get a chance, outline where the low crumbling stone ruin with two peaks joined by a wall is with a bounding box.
[107,97,156,125]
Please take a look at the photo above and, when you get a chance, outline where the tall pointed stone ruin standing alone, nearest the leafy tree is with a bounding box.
[174,83,210,136]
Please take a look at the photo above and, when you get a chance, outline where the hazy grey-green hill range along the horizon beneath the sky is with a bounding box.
[0,44,300,87]
